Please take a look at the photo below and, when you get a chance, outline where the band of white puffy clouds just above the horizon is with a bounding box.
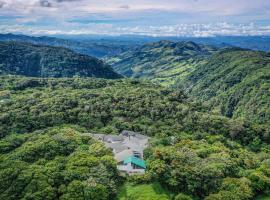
[0,23,270,37]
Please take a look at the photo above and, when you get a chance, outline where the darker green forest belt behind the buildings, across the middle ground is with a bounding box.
[0,76,269,144]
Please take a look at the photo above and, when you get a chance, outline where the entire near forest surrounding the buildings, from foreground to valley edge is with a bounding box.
[0,76,270,200]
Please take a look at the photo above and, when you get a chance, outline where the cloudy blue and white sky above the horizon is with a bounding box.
[0,0,270,37]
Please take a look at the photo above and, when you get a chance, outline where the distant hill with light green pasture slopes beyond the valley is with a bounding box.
[108,41,217,85]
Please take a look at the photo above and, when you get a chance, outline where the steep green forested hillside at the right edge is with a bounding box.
[177,48,270,123]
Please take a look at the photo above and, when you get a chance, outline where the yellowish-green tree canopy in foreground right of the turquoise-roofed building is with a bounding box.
[148,134,270,200]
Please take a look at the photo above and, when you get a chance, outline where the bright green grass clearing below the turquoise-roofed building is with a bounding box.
[117,183,170,200]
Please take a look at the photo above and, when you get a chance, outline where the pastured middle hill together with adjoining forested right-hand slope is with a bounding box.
[109,41,270,123]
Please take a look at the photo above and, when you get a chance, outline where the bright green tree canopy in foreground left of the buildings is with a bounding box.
[0,127,119,200]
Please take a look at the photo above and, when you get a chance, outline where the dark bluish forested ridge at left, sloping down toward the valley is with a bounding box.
[0,42,120,79]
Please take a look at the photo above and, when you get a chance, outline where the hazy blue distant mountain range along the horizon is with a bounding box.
[0,33,270,58]
